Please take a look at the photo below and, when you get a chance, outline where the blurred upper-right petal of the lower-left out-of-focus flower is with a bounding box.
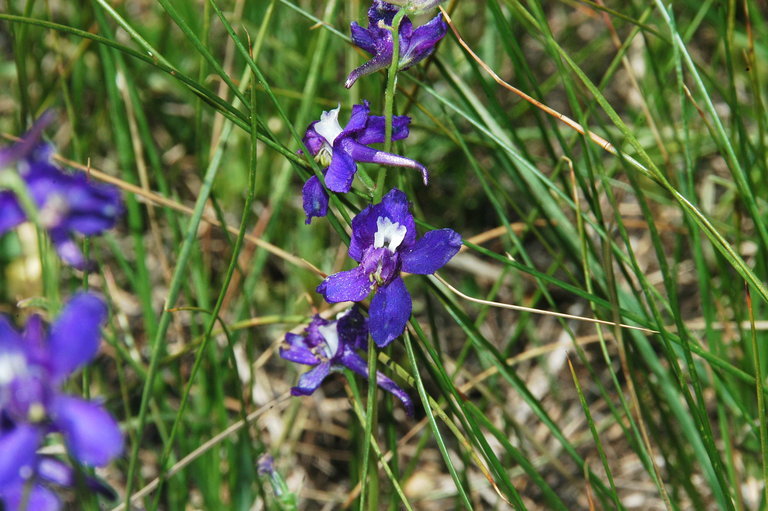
[48,293,107,380]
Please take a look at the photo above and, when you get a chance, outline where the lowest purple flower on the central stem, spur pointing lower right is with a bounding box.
[280,307,413,416]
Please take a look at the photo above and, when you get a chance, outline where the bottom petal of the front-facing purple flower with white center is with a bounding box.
[368,277,412,348]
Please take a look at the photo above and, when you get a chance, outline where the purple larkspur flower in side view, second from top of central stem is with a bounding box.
[302,101,428,223]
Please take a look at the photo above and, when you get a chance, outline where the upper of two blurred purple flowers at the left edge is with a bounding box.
[0,115,122,269]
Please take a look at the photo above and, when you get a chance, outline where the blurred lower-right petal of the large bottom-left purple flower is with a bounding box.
[51,395,123,466]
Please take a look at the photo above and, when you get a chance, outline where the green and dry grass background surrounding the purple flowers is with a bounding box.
[0,0,768,510]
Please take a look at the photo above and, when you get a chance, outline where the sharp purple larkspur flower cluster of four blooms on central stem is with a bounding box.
[280,0,462,415]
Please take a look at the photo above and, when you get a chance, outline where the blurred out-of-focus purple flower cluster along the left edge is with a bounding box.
[0,119,123,511]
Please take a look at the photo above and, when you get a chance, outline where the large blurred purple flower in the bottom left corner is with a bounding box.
[0,293,123,510]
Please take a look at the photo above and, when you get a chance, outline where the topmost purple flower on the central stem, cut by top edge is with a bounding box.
[344,0,448,88]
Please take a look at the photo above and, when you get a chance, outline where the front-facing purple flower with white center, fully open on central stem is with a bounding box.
[317,189,461,346]
